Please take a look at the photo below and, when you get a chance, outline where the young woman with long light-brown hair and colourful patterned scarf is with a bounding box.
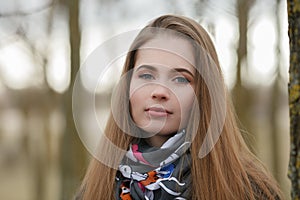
[76,15,283,200]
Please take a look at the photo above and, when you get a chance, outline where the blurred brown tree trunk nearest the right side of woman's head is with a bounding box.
[232,0,254,148]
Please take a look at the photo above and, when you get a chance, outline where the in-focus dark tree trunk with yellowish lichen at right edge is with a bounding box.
[287,0,300,199]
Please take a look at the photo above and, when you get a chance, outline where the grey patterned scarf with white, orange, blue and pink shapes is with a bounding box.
[116,130,191,200]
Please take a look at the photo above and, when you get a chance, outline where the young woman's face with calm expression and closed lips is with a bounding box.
[130,37,196,136]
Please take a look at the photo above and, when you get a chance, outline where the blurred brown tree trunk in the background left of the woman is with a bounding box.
[61,0,86,200]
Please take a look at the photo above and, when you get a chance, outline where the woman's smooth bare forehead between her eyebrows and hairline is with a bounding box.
[135,36,195,71]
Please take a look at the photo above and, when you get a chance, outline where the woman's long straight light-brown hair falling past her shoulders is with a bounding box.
[77,15,283,200]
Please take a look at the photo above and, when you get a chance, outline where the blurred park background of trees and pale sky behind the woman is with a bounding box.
[0,0,290,200]
